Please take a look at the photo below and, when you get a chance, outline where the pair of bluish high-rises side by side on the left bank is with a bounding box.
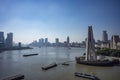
[0,32,13,48]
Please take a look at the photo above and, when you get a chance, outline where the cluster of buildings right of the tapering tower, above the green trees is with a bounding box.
[96,31,120,49]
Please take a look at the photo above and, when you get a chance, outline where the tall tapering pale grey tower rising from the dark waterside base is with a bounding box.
[85,26,97,61]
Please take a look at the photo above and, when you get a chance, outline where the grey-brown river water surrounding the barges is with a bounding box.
[0,47,120,80]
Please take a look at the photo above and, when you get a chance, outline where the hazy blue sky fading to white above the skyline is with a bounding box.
[0,0,120,43]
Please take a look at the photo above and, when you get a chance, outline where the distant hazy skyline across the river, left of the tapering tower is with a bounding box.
[30,36,81,47]
